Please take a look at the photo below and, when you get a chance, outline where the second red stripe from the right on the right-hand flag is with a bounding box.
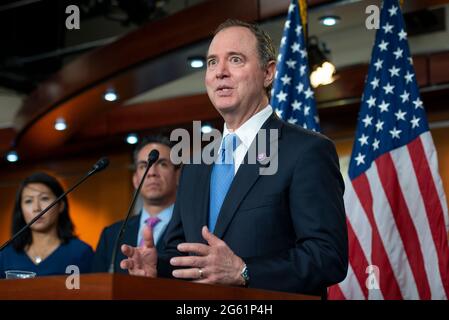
[376,153,431,299]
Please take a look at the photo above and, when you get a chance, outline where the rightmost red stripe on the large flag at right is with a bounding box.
[408,138,449,298]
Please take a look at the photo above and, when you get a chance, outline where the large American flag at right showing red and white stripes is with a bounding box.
[329,0,449,299]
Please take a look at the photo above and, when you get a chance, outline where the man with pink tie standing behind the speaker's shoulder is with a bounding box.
[92,135,180,272]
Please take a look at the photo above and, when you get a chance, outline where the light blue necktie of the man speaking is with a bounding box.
[209,133,239,232]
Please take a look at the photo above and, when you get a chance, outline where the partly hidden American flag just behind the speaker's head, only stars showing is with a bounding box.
[271,0,320,131]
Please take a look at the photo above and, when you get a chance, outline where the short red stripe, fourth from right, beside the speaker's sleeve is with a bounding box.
[346,220,368,299]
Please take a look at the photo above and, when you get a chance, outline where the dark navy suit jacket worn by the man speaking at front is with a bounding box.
[158,114,348,295]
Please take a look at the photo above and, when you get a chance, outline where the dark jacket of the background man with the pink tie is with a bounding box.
[92,214,167,273]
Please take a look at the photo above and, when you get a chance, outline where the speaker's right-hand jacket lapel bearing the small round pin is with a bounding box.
[214,113,283,238]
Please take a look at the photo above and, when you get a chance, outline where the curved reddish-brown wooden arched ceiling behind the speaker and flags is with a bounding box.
[0,0,449,164]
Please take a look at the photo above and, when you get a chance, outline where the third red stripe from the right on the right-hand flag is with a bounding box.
[352,173,402,299]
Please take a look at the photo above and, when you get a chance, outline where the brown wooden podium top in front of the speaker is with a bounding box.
[0,273,320,300]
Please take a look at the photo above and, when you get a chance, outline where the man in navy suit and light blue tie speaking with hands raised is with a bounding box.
[121,20,348,295]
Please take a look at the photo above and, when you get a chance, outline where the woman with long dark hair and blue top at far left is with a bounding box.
[0,172,93,278]
